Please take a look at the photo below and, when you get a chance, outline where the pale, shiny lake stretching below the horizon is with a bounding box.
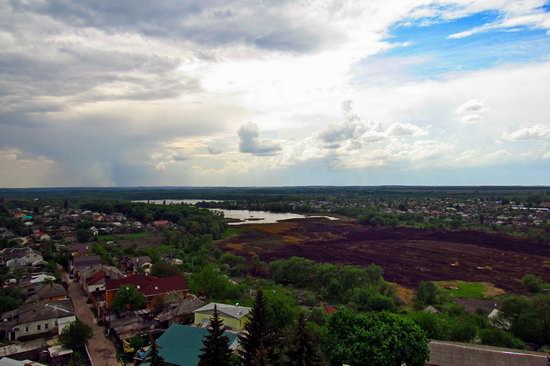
[133,200,338,226]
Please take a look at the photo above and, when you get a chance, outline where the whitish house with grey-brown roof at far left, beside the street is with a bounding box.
[0,300,76,341]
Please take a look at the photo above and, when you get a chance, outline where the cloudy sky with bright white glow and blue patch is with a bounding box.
[0,0,550,187]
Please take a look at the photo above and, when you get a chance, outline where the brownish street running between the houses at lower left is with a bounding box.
[69,274,118,366]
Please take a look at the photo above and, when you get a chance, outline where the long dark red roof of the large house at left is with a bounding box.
[105,274,188,296]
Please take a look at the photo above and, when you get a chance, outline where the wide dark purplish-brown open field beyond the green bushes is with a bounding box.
[218,219,550,291]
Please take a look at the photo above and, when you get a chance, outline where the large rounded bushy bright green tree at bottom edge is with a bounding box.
[325,309,429,366]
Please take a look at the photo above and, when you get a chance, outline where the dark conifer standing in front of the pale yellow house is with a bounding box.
[199,305,231,366]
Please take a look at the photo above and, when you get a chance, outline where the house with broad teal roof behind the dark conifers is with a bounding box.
[138,324,239,366]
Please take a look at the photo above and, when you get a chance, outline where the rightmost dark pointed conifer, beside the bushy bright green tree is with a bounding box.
[287,313,323,366]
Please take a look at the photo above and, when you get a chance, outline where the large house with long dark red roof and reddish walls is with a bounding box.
[105,274,189,309]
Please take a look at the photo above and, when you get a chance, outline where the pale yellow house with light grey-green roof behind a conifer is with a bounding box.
[193,302,252,331]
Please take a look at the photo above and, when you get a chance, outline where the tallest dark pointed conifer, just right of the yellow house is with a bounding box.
[239,290,276,366]
